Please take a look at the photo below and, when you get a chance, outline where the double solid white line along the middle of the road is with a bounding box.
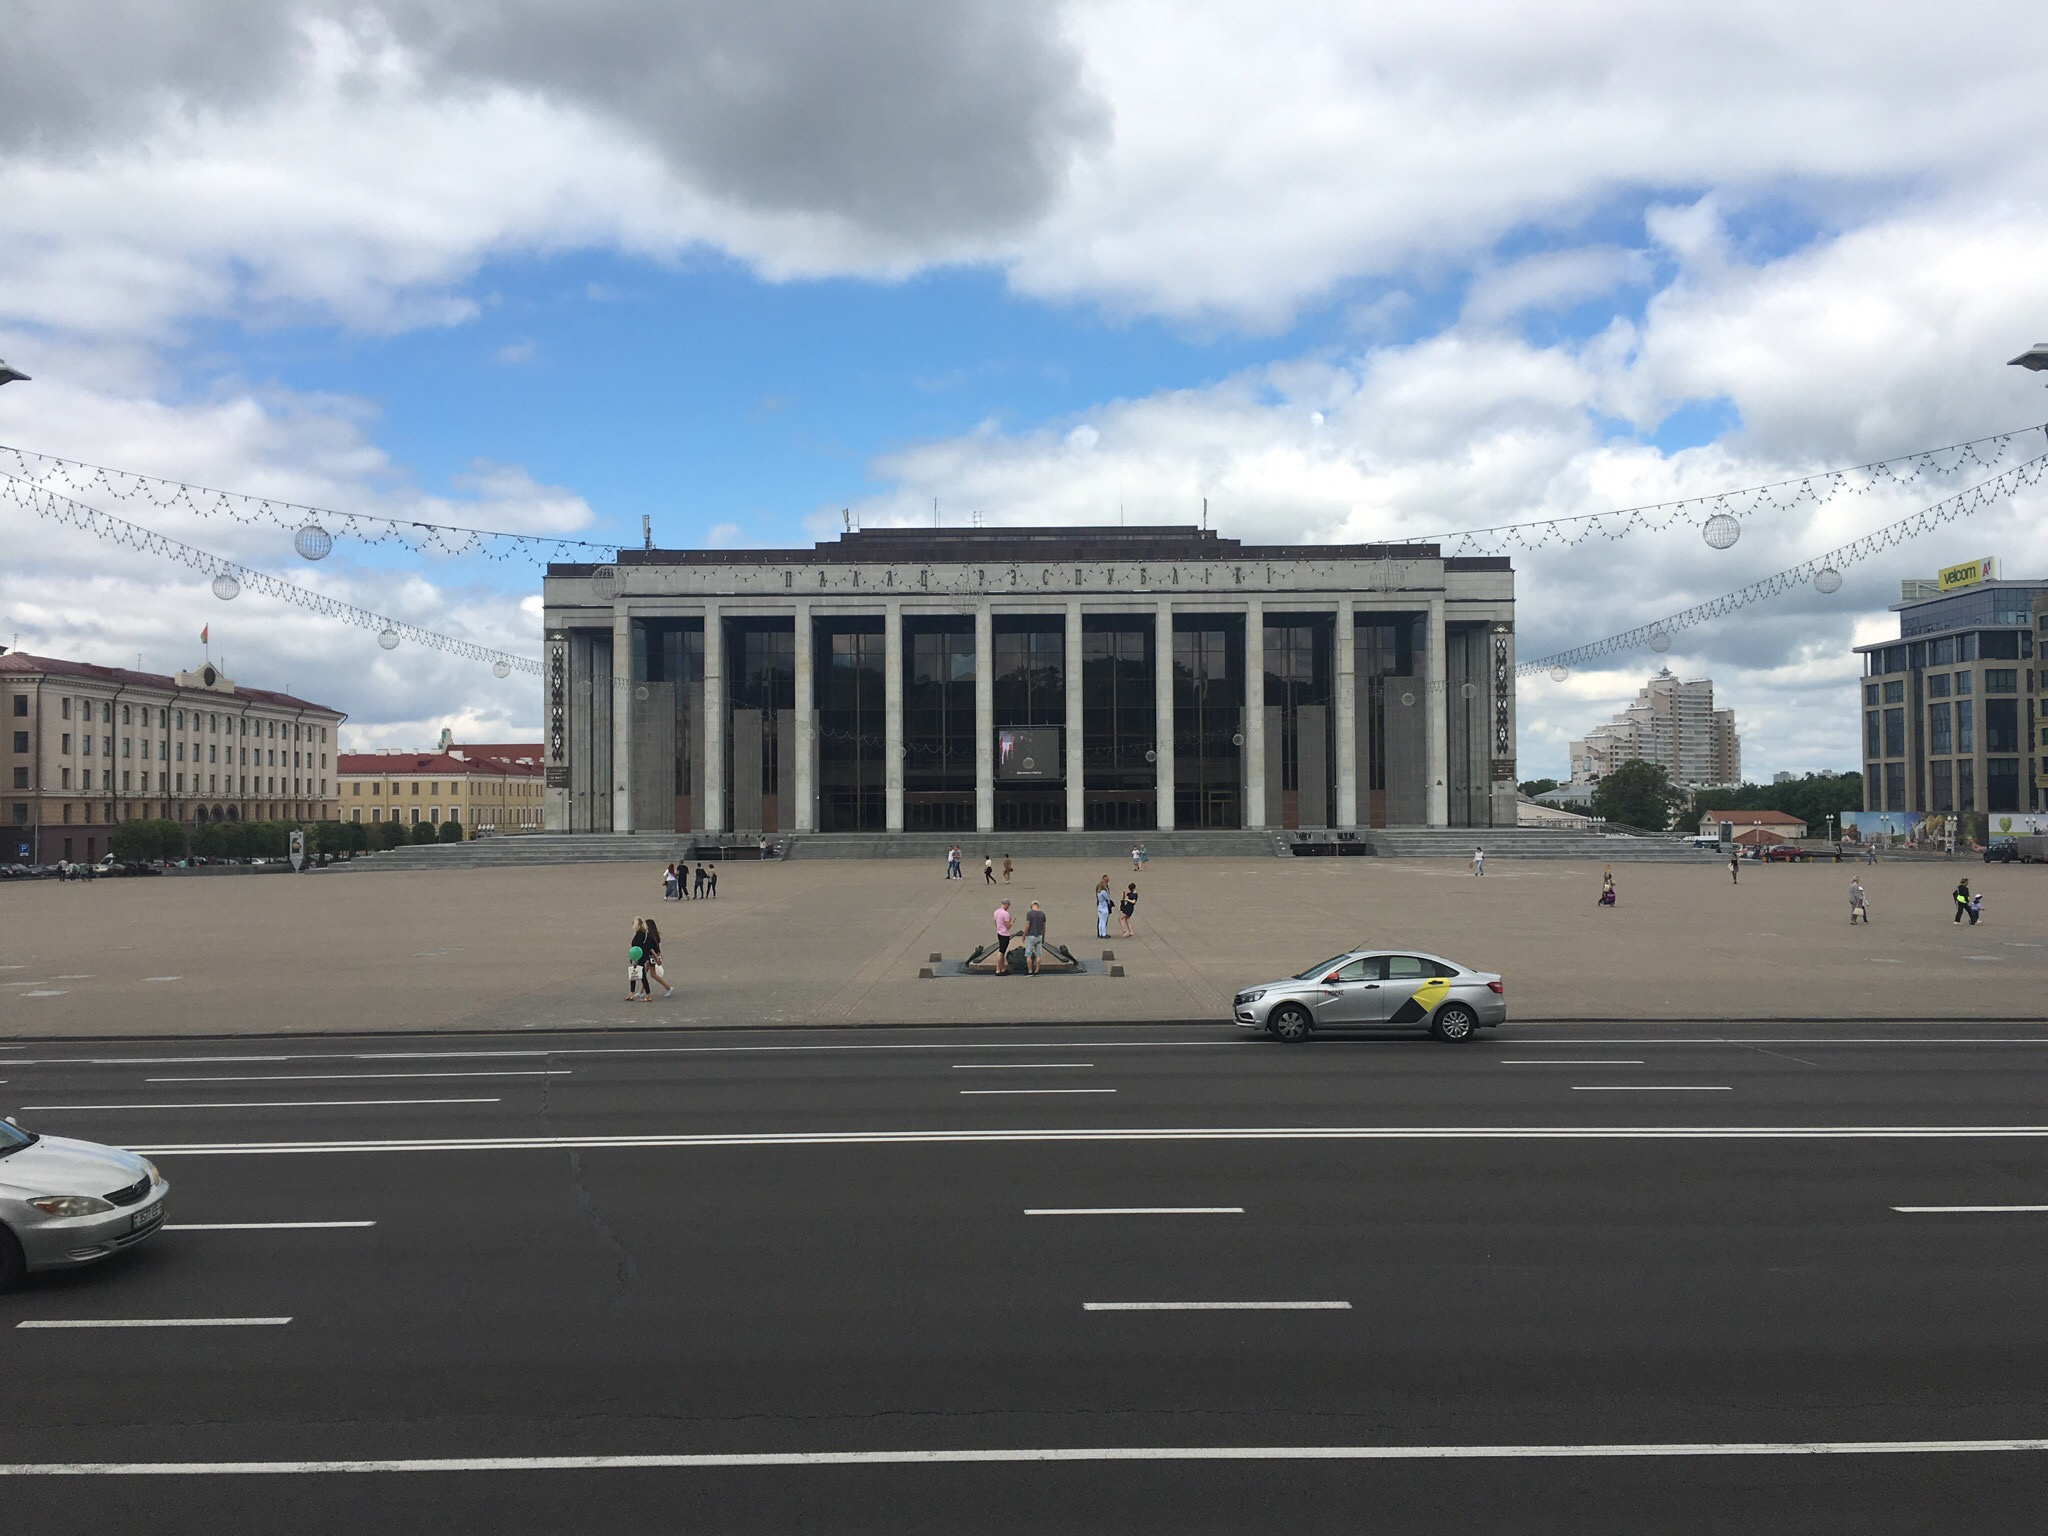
[129,1124,2048,1157]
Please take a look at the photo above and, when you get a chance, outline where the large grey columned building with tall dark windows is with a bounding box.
[543,526,1516,834]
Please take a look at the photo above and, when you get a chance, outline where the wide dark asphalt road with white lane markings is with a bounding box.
[0,1024,2048,1532]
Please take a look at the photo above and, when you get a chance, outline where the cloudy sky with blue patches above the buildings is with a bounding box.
[0,0,2048,778]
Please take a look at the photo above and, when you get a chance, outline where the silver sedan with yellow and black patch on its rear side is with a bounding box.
[1231,948,1507,1040]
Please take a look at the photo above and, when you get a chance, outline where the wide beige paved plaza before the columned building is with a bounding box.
[0,848,2048,1036]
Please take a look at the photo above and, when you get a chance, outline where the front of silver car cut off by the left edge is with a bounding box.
[0,1120,170,1290]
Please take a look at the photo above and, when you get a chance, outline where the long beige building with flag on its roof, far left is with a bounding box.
[0,651,346,862]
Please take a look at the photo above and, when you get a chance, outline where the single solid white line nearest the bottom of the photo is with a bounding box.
[0,1440,2048,1477]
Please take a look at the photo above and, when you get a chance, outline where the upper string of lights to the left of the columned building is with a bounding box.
[0,442,621,563]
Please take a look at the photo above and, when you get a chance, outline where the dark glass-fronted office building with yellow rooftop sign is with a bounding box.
[1855,582,2048,815]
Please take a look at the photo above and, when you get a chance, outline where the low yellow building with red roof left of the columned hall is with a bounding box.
[340,741,547,836]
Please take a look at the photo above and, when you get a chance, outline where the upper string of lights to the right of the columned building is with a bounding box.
[1433,426,2048,555]
